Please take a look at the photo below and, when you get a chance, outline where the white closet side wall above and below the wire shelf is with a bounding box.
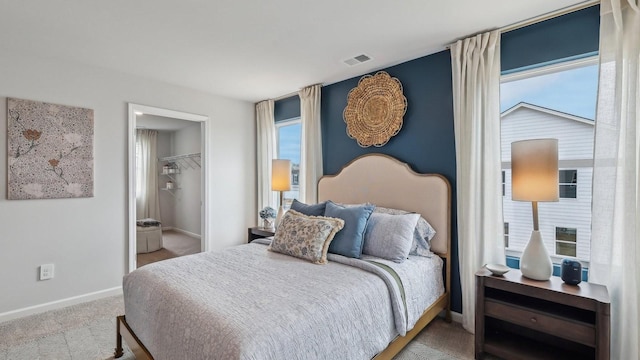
[173,123,202,235]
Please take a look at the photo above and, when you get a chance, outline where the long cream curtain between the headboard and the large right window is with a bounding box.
[451,31,505,332]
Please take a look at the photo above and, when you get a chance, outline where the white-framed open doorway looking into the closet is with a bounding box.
[128,103,210,272]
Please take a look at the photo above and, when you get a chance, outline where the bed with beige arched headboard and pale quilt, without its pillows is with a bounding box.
[115,154,451,360]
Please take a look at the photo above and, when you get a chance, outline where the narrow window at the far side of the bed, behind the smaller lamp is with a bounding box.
[276,118,302,209]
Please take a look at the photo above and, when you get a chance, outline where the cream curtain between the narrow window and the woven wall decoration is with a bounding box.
[298,85,322,204]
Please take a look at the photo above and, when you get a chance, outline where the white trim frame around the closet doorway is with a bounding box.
[127,103,211,273]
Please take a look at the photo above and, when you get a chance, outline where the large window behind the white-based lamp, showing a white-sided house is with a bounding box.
[500,58,598,262]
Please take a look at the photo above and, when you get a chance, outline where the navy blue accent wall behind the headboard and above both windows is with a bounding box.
[282,6,599,312]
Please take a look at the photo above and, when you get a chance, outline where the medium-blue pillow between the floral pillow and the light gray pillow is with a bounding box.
[324,201,376,259]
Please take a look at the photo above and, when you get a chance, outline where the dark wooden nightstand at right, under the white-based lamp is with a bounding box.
[475,269,610,359]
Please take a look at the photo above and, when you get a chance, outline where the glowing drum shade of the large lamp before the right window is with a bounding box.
[511,139,559,201]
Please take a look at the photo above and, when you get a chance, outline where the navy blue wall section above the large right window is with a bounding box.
[500,5,600,72]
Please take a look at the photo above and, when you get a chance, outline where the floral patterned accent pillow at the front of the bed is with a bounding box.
[269,210,344,264]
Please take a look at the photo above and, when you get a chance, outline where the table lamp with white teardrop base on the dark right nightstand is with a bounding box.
[511,139,559,280]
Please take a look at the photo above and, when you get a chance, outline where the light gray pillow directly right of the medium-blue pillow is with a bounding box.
[362,212,420,263]
